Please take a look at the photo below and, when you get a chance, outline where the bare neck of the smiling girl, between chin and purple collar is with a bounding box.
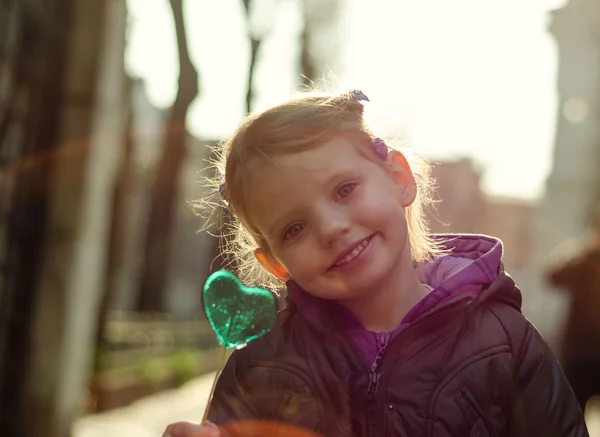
[340,251,428,332]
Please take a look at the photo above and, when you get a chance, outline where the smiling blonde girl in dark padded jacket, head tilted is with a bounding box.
[165,91,587,437]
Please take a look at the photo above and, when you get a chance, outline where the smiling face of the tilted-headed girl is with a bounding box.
[247,138,416,300]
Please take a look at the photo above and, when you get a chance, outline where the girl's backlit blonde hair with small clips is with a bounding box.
[197,93,443,289]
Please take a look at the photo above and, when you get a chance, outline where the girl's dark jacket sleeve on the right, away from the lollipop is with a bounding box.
[502,310,588,437]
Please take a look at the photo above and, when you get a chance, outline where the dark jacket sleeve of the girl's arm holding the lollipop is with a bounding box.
[208,349,323,433]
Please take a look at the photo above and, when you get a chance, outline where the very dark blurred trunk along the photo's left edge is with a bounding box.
[0,0,75,437]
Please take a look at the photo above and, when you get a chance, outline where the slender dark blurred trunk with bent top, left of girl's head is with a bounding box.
[137,0,198,312]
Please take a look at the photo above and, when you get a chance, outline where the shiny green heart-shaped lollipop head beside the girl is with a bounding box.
[202,270,277,349]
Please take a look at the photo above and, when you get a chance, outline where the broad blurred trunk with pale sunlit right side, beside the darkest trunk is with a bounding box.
[23,0,126,437]
